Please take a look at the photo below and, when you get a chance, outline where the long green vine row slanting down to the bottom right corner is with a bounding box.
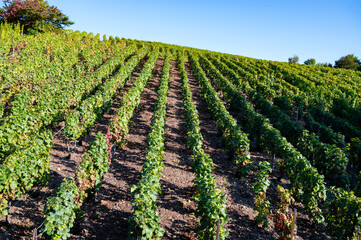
[198,52,361,238]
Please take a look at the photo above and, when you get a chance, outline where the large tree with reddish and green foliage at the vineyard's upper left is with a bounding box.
[0,0,73,33]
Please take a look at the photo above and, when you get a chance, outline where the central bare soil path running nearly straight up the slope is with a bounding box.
[158,60,195,239]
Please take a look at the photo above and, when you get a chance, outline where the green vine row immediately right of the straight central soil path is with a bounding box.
[177,53,228,239]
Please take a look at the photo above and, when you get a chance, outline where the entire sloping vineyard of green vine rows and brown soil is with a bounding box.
[0,21,361,239]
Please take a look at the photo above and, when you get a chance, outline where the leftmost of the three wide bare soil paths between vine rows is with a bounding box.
[72,58,163,239]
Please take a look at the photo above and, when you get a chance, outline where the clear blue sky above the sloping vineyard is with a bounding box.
[7,0,361,64]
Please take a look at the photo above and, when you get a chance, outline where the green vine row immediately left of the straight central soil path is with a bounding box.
[129,52,171,239]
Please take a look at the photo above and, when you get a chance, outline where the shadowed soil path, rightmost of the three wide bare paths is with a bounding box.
[185,63,275,240]
